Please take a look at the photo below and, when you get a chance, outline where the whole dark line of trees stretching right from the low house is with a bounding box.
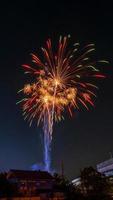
[53,167,113,200]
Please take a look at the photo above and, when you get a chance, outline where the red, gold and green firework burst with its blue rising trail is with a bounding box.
[18,37,107,171]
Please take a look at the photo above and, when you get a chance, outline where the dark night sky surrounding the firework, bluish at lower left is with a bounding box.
[0,0,113,178]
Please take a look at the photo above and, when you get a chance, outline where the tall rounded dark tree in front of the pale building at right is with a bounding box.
[80,167,109,200]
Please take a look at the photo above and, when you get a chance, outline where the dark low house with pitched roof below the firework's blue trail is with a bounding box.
[7,170,54,196]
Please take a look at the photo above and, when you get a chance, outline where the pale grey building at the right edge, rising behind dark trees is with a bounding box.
[97,158,113,176]
